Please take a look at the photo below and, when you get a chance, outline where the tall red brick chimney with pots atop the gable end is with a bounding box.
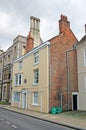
[59,15,70,34]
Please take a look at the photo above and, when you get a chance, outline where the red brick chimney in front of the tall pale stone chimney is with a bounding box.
[26,32,34,53]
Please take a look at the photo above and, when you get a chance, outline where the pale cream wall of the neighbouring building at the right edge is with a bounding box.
[77,42,86,110]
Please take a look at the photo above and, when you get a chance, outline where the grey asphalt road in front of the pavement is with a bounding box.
[0,108,73,130]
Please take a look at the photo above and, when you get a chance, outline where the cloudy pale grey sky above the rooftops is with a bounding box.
[0,0,86,51]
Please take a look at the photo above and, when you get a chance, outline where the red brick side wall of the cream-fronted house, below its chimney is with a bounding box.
[49,15,77,110]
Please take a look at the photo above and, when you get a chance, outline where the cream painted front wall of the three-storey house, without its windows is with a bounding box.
[12,46,49,113]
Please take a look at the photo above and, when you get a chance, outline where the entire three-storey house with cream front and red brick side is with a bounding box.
[12,15,78,113]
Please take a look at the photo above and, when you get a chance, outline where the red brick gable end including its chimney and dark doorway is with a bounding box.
[49,15,78,110]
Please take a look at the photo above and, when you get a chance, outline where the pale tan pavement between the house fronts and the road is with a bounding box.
[0,105,86,130]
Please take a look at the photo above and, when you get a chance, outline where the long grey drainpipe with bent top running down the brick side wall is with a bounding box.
[66,46,75,110]
